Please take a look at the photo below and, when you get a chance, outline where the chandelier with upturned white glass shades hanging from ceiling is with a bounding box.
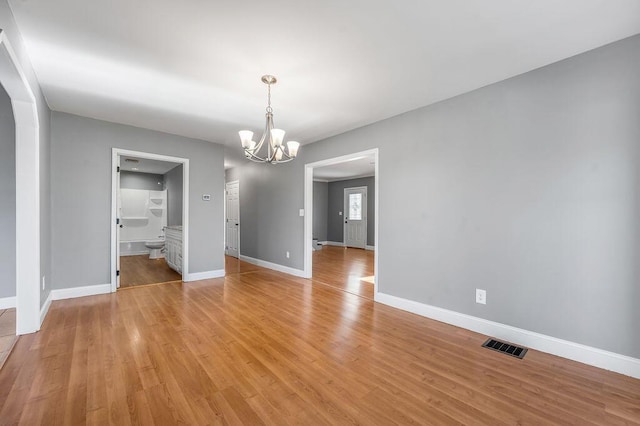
[238,75,300,164]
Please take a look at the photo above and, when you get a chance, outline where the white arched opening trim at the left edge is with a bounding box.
[0,30,40,334]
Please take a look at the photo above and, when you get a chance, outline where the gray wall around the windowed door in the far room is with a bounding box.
[327,176,376,246]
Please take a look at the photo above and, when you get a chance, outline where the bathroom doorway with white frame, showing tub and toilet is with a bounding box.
[112,149,188,291]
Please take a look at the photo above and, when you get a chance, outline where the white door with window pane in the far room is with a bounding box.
[344,186,367,249]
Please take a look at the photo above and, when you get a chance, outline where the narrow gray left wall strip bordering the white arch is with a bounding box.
[0,0,51,306]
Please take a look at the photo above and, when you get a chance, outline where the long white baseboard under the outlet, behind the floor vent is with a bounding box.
[375,293,640,378]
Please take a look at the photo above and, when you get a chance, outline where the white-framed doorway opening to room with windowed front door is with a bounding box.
[304,149,379,299]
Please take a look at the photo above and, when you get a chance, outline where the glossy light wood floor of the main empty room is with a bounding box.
[0,253,640,425]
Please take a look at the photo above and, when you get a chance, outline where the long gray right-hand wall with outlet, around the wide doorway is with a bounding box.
[228,36,640,358]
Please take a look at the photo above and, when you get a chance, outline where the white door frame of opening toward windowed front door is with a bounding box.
[302,148,380,297]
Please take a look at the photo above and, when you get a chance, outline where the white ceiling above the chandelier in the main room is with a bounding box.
[10,0,640,169]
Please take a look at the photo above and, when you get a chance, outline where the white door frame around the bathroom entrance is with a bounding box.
[111,148,189,293]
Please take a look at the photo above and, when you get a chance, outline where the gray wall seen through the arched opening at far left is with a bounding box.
[0,85,16,298]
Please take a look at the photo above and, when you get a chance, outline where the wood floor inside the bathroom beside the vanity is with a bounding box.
[120,254,182,288]
